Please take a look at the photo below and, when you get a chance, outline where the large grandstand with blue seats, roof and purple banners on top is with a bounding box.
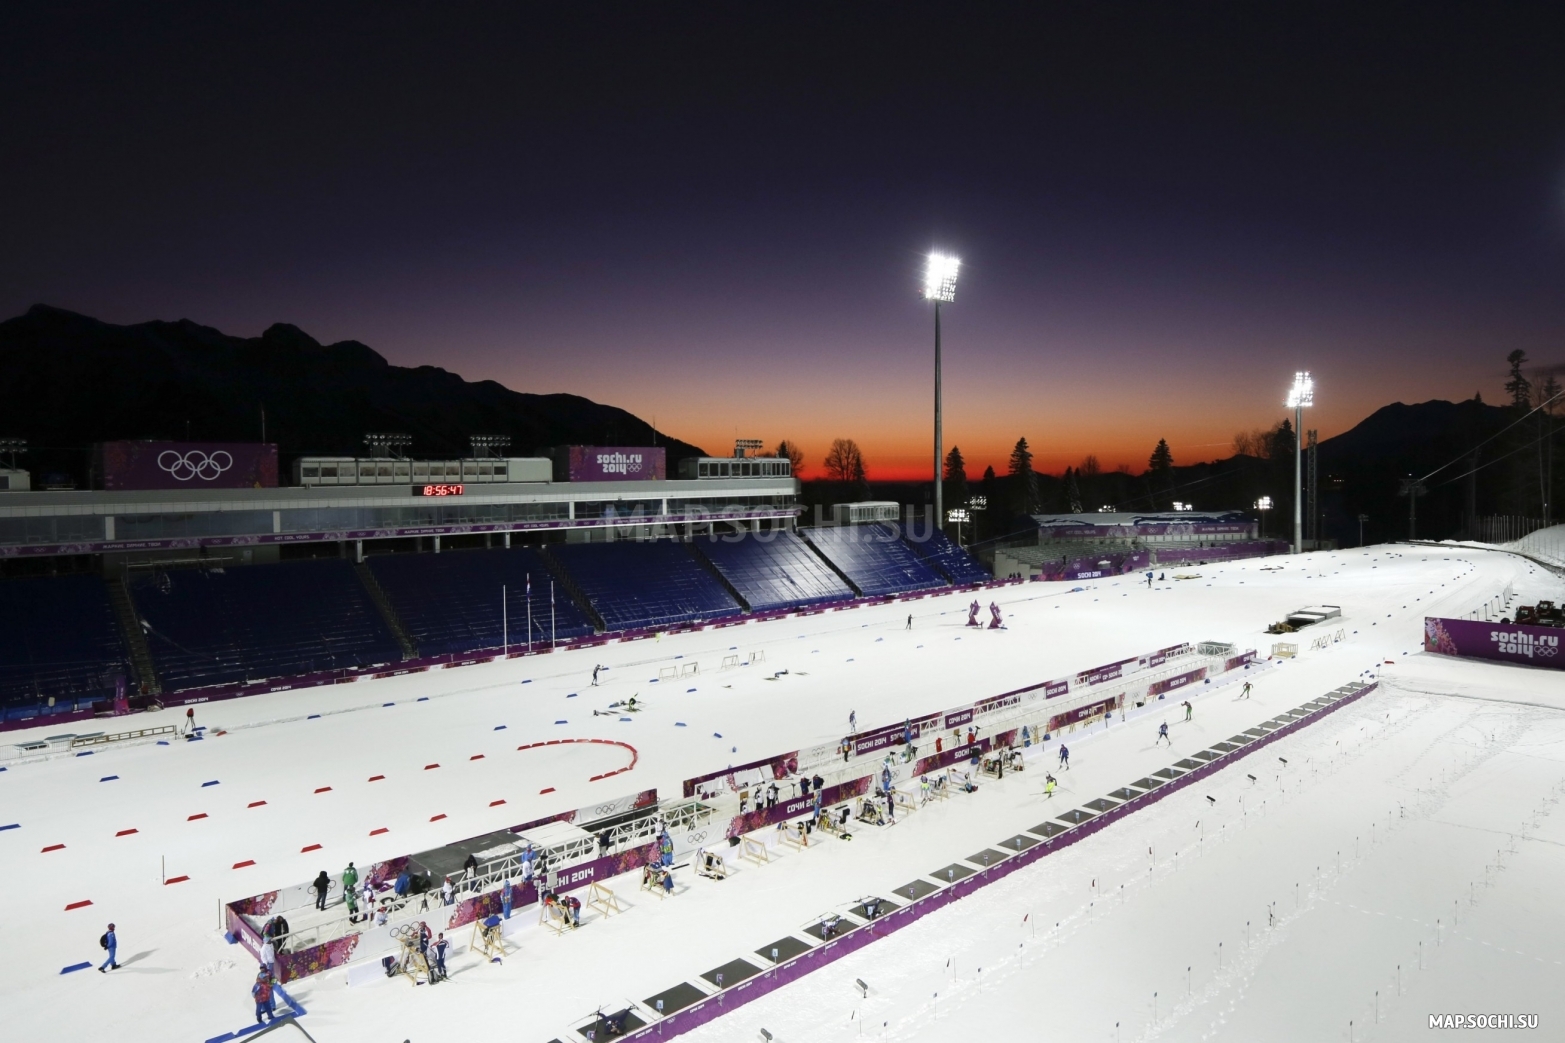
[0,435,991,722]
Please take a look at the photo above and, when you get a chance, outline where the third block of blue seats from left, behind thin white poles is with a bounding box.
[366,547,593,656]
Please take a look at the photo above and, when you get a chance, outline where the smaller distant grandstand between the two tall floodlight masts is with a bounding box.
[986,511,1288,579]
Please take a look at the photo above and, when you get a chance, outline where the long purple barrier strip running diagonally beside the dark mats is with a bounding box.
[623,684,1376,1040]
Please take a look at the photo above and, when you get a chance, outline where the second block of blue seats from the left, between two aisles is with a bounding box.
[130,559,402,691]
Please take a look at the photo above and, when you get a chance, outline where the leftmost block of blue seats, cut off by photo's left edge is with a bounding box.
[0,575,130,711]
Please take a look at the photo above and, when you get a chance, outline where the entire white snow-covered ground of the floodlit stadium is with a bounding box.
[0,547,1565,1043]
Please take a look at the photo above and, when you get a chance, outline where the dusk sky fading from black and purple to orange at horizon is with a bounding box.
[0,3,1565,478]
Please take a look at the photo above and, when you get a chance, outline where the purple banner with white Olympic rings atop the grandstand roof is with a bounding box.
[95,442,277,490]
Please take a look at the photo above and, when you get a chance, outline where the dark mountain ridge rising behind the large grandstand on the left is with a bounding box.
[0,305,703,482]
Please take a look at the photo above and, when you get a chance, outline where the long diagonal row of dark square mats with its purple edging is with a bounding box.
[563,681,1377,1043]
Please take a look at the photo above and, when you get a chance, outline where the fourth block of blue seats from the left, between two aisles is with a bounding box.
[549,540,743,630]
